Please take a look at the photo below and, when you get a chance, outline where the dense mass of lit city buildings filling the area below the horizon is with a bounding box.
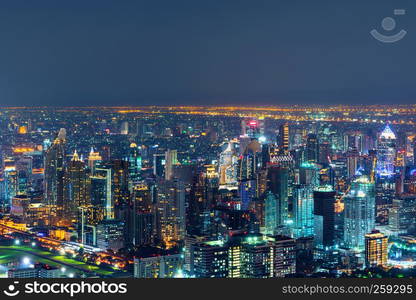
[0,109,416,278]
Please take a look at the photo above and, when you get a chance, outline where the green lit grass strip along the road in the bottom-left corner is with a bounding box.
[0,246,114,276]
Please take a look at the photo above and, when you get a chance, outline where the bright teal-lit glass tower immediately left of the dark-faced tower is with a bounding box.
[292,185,314,238]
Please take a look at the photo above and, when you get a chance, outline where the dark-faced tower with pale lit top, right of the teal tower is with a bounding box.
[313,186,336,248]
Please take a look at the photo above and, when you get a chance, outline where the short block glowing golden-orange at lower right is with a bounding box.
[365,230,388,267]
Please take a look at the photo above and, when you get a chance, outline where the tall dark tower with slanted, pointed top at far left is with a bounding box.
[44,128,66,217]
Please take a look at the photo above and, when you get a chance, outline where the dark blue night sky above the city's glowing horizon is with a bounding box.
[0,0,416,106]
